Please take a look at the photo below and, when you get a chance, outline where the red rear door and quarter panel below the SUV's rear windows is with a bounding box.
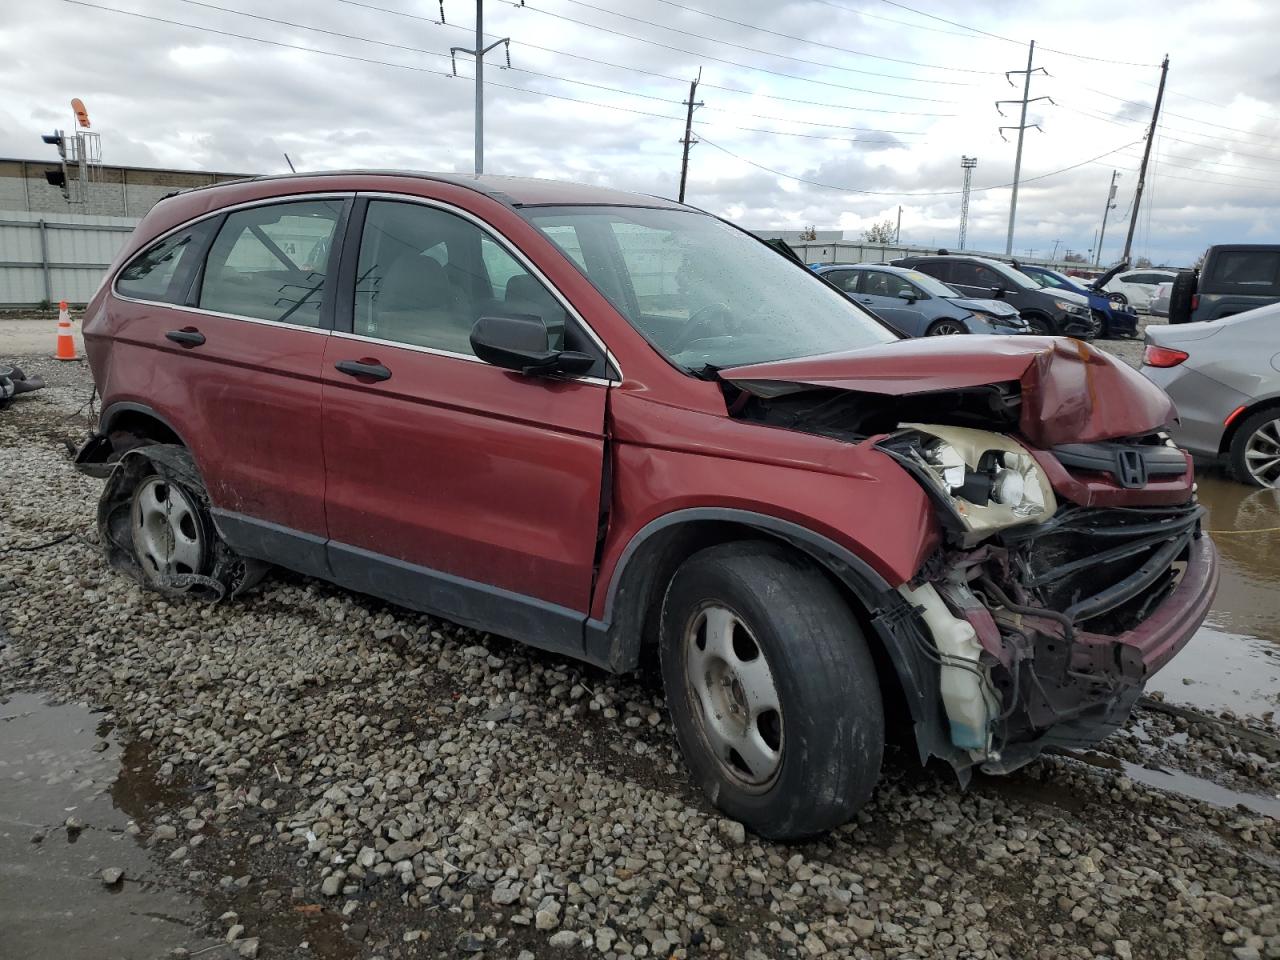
[84,297,328,536]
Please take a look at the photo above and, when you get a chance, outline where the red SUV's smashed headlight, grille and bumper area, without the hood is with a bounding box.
[877,425,1216,772]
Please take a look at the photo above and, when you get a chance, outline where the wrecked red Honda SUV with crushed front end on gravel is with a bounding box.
[78,173,1216,837]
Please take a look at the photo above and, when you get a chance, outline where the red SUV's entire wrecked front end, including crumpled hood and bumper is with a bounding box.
[722,338,1217,776]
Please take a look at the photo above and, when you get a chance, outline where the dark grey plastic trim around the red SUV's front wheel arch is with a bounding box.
[584,507,968,764]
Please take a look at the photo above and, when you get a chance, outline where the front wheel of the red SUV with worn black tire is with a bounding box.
[660,541,884,840]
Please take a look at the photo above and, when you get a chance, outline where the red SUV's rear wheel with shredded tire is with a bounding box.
[97,444,269,602]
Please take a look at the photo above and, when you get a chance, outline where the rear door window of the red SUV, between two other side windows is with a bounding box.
[200,200,343,326]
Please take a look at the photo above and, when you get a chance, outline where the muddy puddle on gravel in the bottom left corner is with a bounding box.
[0,694,212,960]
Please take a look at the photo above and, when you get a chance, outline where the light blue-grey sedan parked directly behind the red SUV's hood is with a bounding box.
[813,264,1032,337]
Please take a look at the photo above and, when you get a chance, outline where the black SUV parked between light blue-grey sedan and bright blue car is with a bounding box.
[892,256,1098,340]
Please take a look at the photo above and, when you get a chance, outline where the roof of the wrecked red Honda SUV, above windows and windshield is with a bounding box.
[172,170,692,210]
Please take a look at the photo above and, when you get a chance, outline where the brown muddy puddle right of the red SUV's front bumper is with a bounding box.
[1148,468,1280,716]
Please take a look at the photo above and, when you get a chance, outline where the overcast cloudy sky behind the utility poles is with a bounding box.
[0,0,1280,264]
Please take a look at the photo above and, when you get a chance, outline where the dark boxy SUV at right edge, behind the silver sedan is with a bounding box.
[1169,243,1280,324]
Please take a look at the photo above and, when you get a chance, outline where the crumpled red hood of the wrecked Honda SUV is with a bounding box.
[719,337,1175,448]
